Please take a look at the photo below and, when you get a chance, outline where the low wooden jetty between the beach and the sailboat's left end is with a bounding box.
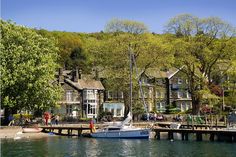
[40,125,90,136]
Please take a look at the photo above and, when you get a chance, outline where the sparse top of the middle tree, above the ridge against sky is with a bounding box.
[105,18,148,34]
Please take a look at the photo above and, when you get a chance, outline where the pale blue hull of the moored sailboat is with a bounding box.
[91,129,150,139]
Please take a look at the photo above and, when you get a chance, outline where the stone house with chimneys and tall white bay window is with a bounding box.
[56,69,105,118]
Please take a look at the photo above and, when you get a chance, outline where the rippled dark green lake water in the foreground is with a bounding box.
[1,136,236,157]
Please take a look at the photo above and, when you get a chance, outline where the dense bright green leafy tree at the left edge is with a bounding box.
[0,20,60,115]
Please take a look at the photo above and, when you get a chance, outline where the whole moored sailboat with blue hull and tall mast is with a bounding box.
[91,47,150,139]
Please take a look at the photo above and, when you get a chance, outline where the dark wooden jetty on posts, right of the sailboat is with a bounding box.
[152,128,236,142]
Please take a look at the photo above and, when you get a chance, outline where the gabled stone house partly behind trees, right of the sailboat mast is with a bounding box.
[141,68,192,112]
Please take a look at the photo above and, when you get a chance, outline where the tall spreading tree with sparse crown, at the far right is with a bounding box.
[166,14,236,114]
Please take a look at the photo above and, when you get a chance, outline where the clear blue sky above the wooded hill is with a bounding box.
[1,0,236,33]
